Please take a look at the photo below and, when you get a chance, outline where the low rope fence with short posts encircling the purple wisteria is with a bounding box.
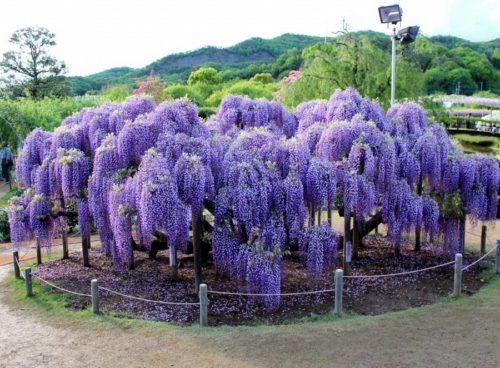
[7,237,500,326]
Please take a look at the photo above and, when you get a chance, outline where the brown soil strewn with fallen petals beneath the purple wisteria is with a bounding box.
[29,237,483,325]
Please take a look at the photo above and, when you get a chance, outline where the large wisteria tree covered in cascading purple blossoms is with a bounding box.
[8,89,500,309]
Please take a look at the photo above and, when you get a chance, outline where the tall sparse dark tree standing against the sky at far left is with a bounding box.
[0,27,69,98]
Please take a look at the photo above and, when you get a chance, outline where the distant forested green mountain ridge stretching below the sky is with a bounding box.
[68,31,500,95]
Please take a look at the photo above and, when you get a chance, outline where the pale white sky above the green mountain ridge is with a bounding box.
[0,0,500,75]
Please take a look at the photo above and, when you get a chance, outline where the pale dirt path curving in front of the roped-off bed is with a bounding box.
[0,267,500,368]
